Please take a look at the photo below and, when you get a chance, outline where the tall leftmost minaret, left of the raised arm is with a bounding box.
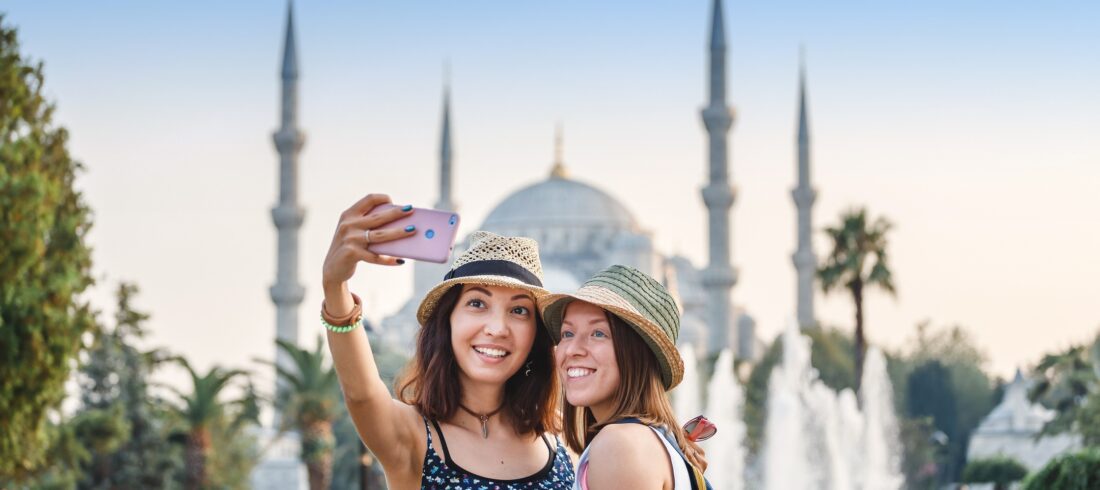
[271,4,306,420]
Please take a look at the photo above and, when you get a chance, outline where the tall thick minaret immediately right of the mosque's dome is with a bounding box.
[702,0,737,353]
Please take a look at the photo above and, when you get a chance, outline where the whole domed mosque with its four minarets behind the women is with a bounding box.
[252,0,816,488]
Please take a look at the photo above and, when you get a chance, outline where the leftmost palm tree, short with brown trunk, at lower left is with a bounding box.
[173,358,260,489]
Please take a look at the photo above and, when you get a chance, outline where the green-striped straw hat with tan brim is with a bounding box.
[539,265,684,390]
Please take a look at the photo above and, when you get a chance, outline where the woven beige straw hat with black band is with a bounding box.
[416,231,549,326]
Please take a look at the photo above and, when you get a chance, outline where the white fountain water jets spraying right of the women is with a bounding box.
[672,320,904,490]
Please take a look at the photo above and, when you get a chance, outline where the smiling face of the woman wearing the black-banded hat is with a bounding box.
[451,284,538,385]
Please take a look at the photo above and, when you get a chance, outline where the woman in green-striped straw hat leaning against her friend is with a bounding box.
[539,265,713,490]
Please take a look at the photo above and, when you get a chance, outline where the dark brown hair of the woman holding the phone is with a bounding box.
[394,284,561,434]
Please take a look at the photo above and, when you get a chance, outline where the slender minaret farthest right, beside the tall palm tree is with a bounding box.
[791,51,817,328]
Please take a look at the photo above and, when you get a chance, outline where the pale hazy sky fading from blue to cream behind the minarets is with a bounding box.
[0,0,1100,389]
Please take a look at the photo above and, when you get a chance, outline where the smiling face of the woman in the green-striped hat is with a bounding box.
[554,301,619,421]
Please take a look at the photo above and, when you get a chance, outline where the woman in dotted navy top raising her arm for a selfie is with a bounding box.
[321,194,573,489]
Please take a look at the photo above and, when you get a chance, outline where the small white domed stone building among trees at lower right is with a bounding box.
[967,370,1080,471]
